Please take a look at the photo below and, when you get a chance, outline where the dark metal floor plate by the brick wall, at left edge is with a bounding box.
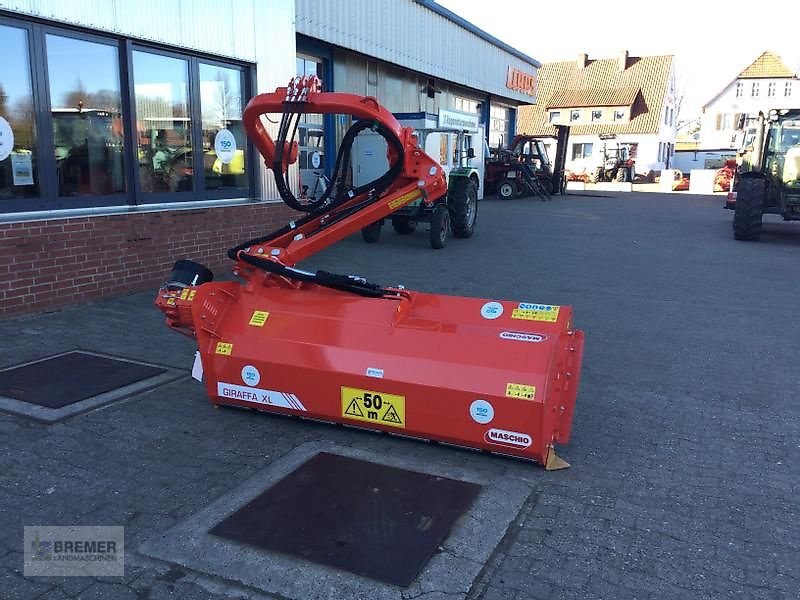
[0,351,166,409]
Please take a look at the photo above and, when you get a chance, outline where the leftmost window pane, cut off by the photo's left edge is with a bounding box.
[0,25,39,199]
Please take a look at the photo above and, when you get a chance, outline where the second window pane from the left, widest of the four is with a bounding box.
[47,35,125,196]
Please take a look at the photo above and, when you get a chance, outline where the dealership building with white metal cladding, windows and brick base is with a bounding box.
[0,0,539,316]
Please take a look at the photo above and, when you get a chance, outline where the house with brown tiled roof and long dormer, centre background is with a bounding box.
[517,51,677,174]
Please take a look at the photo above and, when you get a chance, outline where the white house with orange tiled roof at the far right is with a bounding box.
[699,51,800,150]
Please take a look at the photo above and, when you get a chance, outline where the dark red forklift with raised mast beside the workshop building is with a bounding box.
[486,125,569,200]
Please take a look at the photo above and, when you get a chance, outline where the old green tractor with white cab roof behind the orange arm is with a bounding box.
[361,129,483,249]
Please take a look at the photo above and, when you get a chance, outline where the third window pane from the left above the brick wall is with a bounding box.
[133,50,194,192]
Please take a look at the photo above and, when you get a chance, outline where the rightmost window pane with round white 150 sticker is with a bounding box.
[200,63,249,190]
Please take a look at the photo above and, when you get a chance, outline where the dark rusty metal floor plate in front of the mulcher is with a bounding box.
[210,452,481,587]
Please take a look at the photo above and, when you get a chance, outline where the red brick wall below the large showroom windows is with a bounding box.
[0,203,300,318]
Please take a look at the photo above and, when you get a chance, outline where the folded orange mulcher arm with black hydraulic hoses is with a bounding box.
[229,76,447,267]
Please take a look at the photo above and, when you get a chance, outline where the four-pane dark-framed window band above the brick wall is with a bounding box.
[0,17,253,212]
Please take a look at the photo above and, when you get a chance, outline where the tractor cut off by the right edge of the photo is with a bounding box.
[731,109,800,241]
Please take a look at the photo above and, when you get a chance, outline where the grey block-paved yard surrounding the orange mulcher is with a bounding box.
[0,192,800,600]
